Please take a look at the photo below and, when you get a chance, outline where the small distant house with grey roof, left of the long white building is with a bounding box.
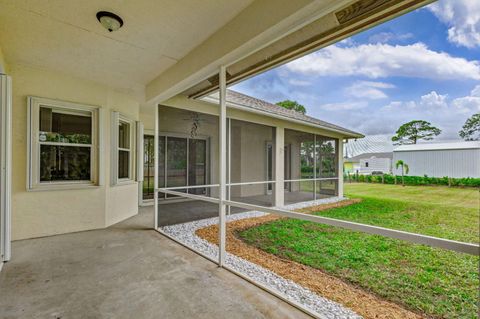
[343,152,393,174]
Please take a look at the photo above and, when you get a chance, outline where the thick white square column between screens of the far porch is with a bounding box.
[274,126,285,207]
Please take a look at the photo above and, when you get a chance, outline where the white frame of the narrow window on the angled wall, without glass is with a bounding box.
[111,111,136,186]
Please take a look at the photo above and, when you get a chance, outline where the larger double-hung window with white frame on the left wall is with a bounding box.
[28,97,99,189]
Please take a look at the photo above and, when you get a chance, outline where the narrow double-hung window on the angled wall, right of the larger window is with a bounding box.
[111,112,135,185]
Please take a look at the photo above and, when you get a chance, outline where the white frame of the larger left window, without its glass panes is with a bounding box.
[27,96,101,191]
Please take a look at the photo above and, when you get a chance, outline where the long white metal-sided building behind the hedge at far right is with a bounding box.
[393,141,480,178]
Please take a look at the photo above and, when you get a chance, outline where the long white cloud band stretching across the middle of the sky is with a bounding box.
[286,43,480,80]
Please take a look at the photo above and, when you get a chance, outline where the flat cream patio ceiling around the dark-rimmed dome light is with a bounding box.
[0,0,253,96]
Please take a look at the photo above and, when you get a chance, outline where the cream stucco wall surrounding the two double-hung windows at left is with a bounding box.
[9,65,139,240]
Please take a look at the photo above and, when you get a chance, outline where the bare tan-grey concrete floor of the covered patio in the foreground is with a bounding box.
[0,207,310,319]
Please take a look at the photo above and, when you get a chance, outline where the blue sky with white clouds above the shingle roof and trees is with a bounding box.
[232,0,480,140]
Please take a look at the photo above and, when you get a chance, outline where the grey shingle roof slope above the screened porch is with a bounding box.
[206,90,363,137]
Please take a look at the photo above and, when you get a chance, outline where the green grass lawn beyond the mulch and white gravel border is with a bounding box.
[239,184,479,318]
